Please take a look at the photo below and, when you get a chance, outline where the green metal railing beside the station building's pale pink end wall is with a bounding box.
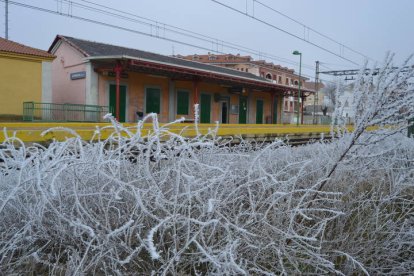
[23,102,112,122]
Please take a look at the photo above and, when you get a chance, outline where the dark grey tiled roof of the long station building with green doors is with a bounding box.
[53,35,268,82]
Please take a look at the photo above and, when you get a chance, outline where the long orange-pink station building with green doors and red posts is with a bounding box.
[49,36,312,124]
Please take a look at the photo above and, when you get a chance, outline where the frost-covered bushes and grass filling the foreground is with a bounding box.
[0,56,414,275]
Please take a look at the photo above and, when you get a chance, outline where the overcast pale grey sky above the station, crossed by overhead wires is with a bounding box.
[0,0,414,82]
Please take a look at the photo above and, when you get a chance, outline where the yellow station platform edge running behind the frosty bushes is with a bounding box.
[0,122,330,143]
